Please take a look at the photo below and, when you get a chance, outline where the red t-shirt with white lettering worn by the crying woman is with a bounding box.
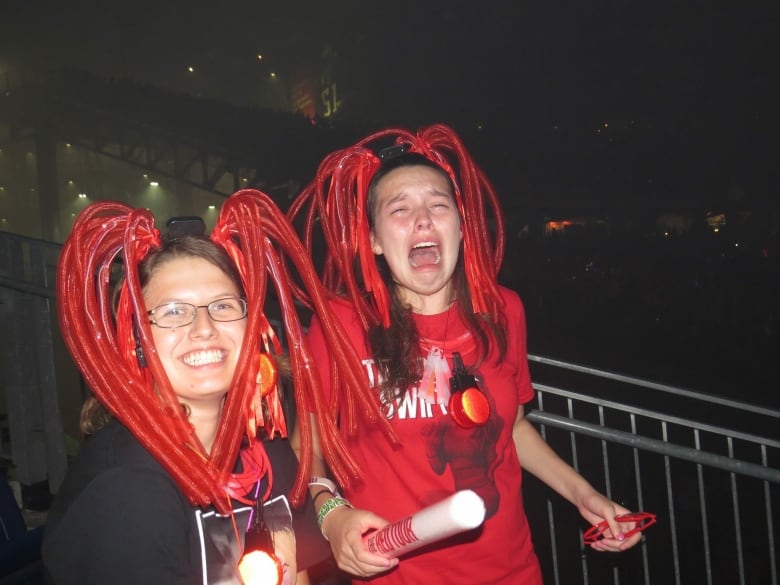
[309,288,542,585]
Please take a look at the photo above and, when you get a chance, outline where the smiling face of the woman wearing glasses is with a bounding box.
[144,256,247,404]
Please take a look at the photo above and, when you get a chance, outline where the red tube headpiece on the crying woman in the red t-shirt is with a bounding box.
[288,124,504,329]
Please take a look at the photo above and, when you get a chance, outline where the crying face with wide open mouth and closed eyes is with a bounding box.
[371,165,462,314]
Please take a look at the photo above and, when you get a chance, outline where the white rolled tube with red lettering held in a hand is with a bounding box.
[365,490,485,557]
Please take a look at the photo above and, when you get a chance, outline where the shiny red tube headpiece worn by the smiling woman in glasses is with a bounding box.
[57,189,374,512]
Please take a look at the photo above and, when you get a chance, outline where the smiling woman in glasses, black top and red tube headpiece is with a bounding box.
[43,190,372,585]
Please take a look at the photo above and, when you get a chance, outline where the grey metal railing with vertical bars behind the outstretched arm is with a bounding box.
[525,356,780,585]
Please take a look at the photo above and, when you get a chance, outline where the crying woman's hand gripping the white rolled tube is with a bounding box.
[322,506,398,577]
